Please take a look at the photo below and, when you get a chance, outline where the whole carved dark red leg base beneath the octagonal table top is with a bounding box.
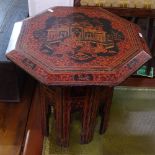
[40,87,113,147]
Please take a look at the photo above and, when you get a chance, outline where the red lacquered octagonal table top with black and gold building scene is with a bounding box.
[7,7,151,85]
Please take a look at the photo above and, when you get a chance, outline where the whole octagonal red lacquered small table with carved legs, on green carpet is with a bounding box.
[7,7,151,146]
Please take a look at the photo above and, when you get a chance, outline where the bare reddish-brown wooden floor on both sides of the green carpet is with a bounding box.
[0,77,155,155]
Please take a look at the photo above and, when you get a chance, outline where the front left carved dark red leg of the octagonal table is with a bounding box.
[55,87,71,147]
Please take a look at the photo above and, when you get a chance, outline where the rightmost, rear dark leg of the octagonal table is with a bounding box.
[100,87,113,134]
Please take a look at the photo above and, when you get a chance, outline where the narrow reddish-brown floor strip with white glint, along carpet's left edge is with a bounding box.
[23,81,43,155]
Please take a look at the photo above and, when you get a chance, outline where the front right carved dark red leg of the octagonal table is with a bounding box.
[81,87,100,144]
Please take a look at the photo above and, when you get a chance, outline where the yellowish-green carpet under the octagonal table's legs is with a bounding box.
[43,87,155,155]
